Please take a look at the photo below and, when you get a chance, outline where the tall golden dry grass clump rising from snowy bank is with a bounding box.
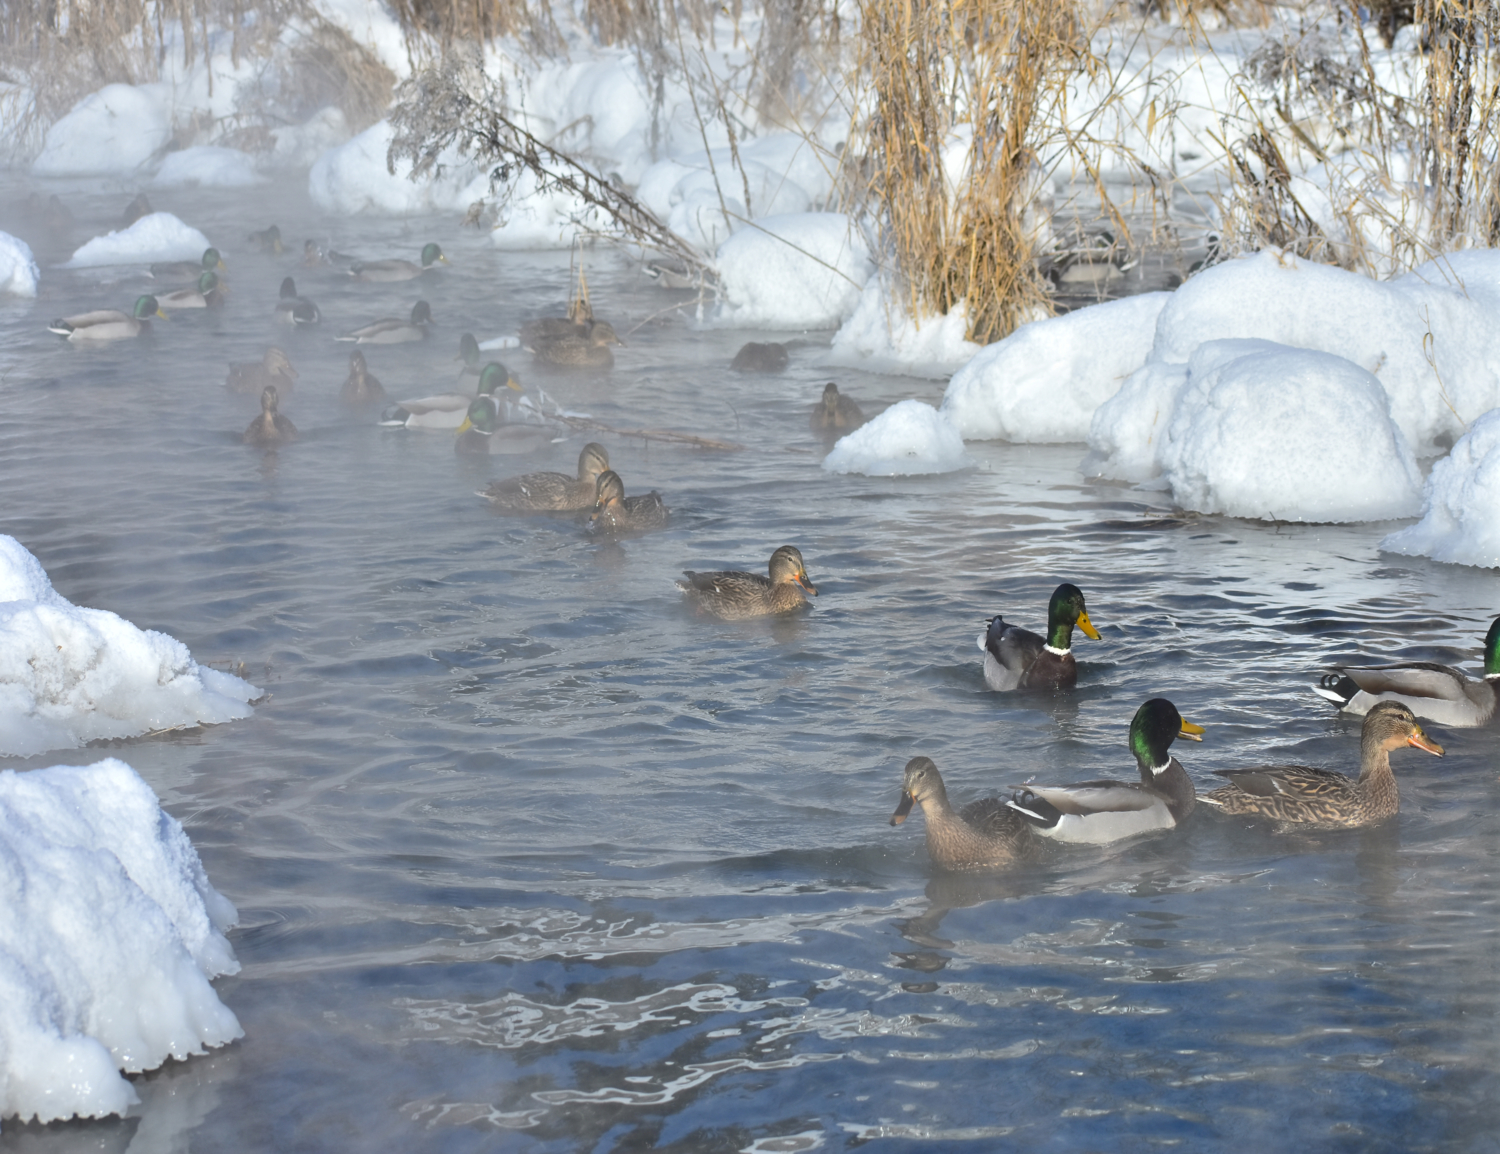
[852,0,1088,342]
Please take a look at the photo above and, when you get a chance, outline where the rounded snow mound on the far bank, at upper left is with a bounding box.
[32,84,170,177]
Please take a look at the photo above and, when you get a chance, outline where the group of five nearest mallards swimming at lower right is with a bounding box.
[891,584,1500,869]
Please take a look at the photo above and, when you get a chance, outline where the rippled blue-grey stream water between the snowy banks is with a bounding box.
[0,175,1500,1154]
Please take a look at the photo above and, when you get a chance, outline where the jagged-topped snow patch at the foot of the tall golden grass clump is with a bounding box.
[830,276,983,377]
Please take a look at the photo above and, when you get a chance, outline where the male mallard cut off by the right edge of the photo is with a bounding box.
[1313,617,1500,726]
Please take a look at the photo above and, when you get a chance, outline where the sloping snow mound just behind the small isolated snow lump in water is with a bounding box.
[942,293,1172,444]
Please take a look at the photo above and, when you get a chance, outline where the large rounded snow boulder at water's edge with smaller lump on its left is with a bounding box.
[1091,341,1422,522]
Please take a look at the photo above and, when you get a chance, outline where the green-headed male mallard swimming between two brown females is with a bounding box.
[1007,698,1203,845]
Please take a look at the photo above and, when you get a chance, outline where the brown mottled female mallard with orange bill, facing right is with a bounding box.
[1203,701,1443,828]
